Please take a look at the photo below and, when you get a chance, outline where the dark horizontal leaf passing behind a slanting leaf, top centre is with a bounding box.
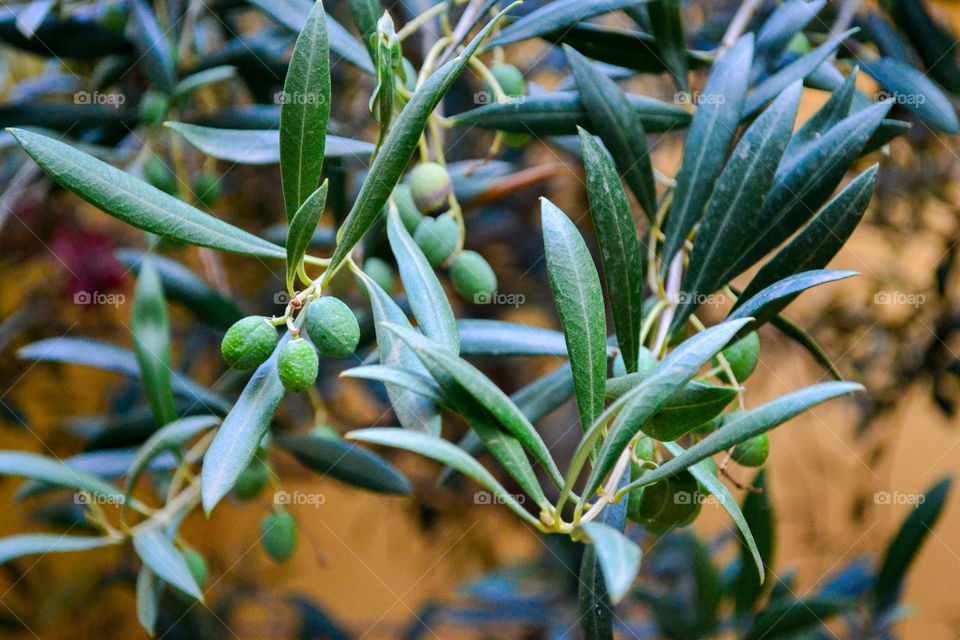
[451,91,691,136]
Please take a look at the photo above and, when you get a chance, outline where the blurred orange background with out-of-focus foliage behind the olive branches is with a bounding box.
[0,0,960,640]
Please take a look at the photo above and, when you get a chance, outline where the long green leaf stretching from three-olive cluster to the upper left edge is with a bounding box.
[10,129,284,258]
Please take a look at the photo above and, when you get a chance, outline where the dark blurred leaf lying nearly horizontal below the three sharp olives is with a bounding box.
[276,436,413,496]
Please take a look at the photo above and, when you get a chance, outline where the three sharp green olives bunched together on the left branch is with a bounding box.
[220,296,360,391]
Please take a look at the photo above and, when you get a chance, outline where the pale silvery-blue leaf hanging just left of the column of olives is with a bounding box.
[387,205,460,355]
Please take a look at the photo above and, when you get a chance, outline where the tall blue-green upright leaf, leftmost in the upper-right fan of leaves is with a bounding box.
[662,34,753,269]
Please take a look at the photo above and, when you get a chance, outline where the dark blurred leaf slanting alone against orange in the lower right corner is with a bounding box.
[873,476,953,611]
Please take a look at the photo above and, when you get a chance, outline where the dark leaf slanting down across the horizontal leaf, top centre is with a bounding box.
[564,46,657,219]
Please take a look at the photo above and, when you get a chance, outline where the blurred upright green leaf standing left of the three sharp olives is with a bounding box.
[130,259,177,425]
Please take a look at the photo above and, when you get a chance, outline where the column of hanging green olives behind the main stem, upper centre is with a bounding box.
[390,162,497,302]
